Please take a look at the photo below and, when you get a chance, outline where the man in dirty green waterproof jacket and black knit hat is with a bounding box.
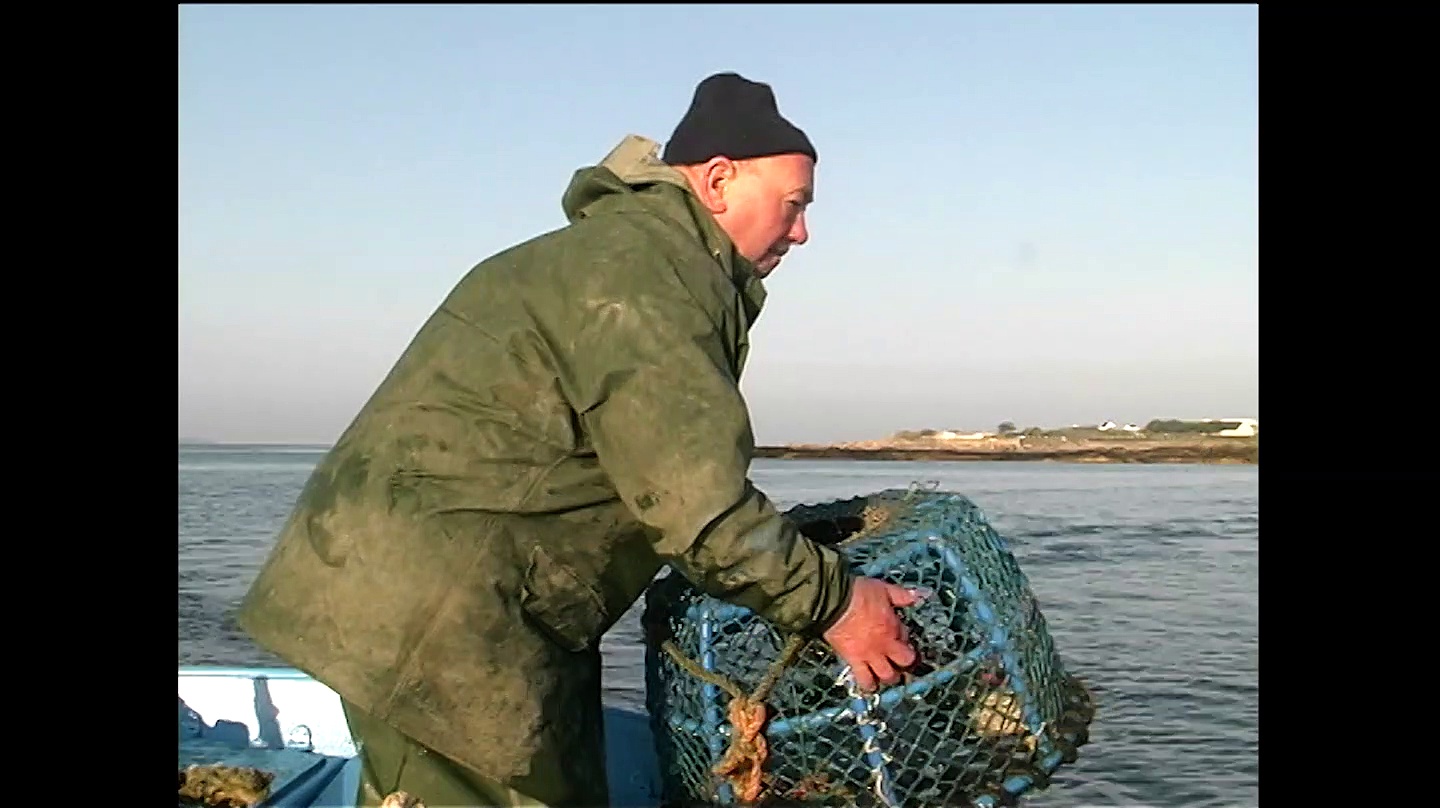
[230,73,914,808]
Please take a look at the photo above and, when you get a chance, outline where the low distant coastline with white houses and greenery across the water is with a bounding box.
[755,421,1260,465]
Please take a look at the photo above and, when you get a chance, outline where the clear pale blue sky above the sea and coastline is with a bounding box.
[179,6,1259,442]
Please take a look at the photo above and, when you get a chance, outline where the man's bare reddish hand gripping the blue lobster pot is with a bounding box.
[825,578,923,693]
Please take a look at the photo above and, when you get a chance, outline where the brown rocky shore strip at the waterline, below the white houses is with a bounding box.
[755,436,1260,465]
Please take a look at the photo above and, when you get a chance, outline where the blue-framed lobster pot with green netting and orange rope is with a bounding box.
[642,488,1094,808]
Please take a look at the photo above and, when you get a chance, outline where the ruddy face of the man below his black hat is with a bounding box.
[716,154,815,278]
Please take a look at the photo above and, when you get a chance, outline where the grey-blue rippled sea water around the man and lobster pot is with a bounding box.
[179,446,1260,808]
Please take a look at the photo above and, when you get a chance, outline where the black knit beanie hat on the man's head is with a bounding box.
[661,73,819,166]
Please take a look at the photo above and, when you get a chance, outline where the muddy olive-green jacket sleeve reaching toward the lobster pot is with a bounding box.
[570,262,851,635]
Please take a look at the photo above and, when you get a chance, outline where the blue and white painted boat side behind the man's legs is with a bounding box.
[179,665,660,808]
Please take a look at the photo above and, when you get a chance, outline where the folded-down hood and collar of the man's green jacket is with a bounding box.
[560,134,765,307]
